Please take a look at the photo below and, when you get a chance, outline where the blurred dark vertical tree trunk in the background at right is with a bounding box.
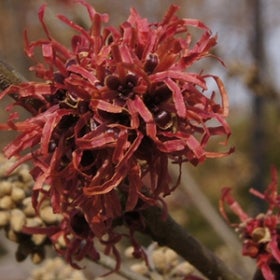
[249,0,267,211]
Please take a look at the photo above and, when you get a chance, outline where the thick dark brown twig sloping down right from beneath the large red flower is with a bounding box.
[143,207,241,280]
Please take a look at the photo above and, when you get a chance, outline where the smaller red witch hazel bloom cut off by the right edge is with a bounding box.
[220,169,280,280]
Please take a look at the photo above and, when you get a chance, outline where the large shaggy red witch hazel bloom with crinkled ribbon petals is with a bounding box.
[1,0,230,262]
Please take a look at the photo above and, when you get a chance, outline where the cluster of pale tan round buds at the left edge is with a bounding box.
[0,155,64,263]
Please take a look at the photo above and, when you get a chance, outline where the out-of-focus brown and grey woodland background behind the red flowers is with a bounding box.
[0,0,280,279]
